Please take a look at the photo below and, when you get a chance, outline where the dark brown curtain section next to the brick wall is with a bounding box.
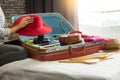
[26,0,53,13]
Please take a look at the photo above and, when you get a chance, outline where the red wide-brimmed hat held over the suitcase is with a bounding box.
[13,14,52,36]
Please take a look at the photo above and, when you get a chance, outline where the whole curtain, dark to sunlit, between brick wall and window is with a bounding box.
[26,0,79,30]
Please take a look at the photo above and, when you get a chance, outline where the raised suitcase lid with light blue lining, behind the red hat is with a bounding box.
[12,13,73,40]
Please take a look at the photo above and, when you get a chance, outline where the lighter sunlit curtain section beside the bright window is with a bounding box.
[53,0,79,30]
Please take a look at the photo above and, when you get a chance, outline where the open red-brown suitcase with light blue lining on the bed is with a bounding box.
[12,13,104,61]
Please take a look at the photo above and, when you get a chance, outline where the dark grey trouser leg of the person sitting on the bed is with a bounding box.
[0,44,28,66]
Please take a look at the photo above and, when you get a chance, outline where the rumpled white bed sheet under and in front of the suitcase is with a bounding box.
[0,52,120,80]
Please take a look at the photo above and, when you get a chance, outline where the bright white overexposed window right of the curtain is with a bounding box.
[78,0,120,27]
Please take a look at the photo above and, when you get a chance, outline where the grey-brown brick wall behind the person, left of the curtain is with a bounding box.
[0,0,26,22]
